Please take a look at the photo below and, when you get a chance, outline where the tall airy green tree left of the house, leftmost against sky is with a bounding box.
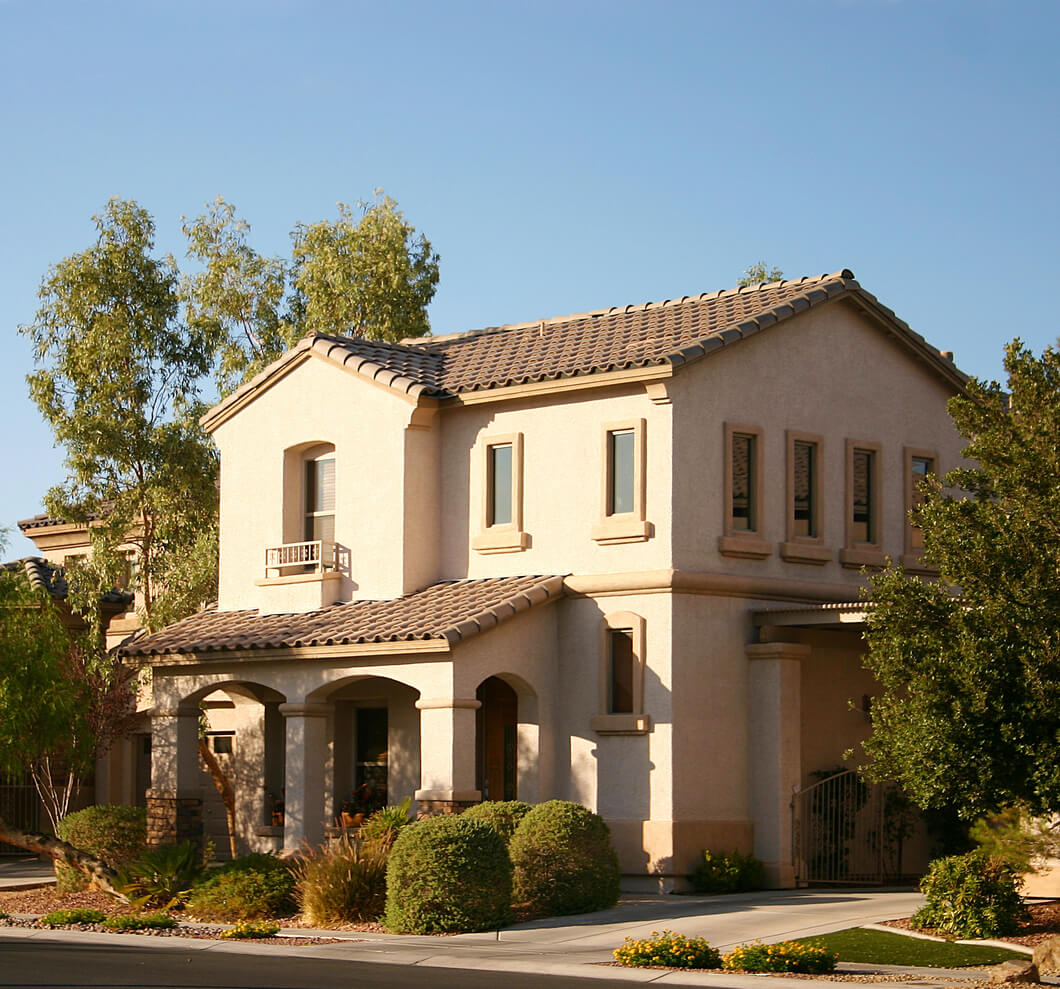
[20,199,217,629]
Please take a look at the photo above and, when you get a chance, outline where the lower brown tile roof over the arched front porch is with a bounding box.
[120,576,563,656]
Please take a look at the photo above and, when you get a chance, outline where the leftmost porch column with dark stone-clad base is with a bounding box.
[147,707,202,845]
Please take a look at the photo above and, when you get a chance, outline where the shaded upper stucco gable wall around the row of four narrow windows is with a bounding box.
[671,303,964,580]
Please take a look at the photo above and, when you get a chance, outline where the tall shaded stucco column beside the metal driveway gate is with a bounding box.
[745,642,810,889]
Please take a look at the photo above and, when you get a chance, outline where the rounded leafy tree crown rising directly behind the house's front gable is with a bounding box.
[293,190,438,341]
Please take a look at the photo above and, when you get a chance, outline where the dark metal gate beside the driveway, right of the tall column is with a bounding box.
[792,770,913,886]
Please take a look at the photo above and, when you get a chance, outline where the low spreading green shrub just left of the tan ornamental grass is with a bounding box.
[186,852,295,920]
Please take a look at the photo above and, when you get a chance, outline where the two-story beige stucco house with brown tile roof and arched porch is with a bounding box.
[121,270,965,888]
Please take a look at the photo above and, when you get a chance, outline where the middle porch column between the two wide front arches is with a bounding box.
[280,704,335,849]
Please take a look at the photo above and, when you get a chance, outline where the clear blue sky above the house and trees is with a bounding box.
[0,0,1060,558]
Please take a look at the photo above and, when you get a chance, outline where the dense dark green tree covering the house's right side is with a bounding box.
[865,340,1060,818]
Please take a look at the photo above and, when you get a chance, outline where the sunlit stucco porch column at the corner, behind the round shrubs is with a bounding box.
[416,697,482,814]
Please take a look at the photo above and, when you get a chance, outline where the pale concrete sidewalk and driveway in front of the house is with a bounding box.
[0,862,1026,989]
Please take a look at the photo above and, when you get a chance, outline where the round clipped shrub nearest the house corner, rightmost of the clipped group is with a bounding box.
[509,800,619,917]
